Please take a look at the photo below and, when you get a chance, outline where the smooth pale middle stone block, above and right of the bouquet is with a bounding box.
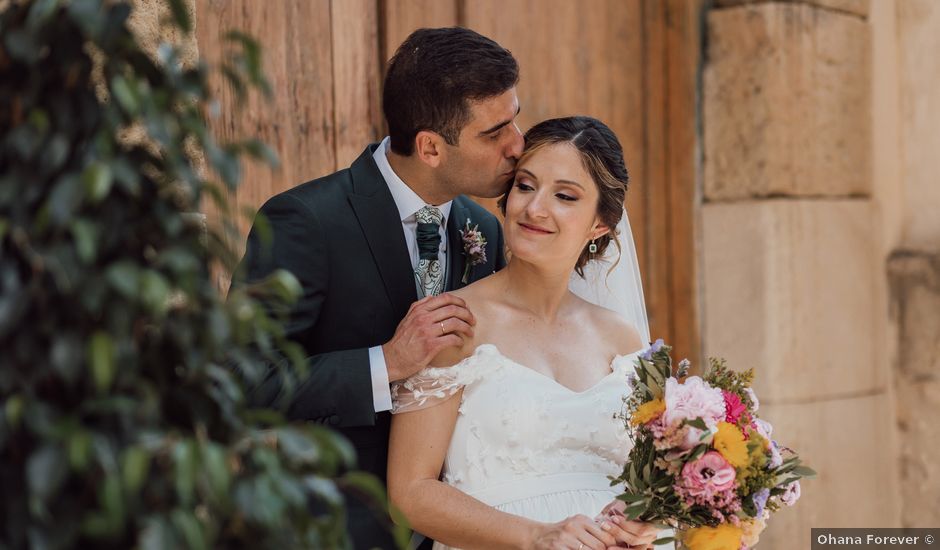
[702,199,889,403]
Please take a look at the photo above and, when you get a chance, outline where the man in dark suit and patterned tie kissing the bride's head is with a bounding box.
[239,28,523,548]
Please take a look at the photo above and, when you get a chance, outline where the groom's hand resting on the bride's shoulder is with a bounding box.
[382,294,476,382]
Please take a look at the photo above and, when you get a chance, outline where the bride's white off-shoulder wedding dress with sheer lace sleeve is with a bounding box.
[392,344,639,549]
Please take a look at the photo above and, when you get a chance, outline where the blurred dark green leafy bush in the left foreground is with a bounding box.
[0,0,400,549]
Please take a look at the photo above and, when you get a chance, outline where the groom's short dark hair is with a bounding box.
[382,27,519,155]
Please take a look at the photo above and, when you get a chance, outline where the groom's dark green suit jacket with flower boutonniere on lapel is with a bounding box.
[238,144,505,548]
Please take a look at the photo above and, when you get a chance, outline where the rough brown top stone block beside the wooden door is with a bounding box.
[703,3,872,200]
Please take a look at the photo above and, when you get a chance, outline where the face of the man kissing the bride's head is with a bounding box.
[441,88,523,202]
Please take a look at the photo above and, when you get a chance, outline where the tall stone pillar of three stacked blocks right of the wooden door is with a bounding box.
[702,0,901,548]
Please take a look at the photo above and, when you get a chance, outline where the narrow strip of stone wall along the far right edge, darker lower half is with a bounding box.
[884,0,940,526]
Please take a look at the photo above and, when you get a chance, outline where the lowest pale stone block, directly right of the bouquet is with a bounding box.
[758,393,900,548]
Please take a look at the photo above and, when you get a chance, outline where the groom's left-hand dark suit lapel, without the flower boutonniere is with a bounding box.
[349,144,418,317]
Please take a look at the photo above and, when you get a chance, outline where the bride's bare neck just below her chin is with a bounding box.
[500,259,571,322]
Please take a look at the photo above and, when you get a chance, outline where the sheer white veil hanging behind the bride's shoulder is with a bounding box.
[568,209,650,346]
